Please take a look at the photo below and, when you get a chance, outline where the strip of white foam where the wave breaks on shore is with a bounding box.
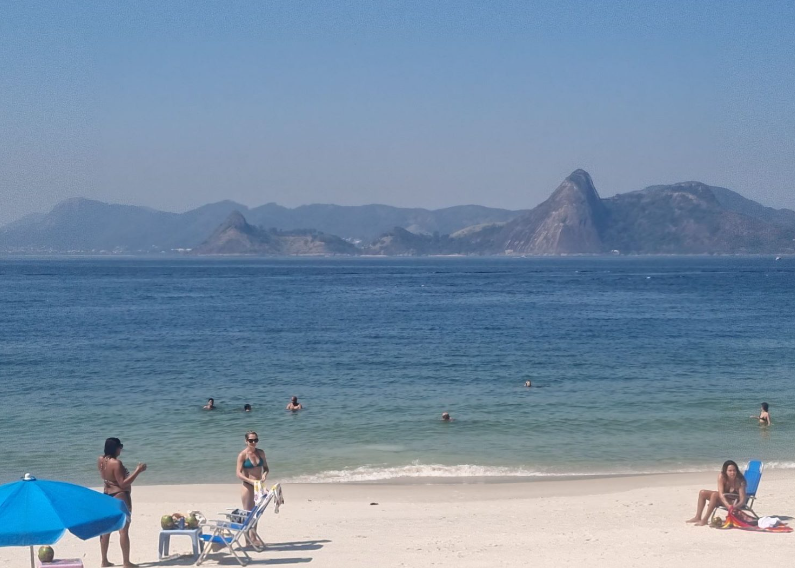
[287,461,728,483]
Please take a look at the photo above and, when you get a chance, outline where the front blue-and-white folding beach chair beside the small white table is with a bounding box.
[196,491,276,566]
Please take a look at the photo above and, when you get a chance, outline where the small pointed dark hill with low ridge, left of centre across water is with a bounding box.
[193,211,359,256]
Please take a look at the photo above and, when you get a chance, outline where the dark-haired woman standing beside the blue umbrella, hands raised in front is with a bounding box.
[97,438,146,568]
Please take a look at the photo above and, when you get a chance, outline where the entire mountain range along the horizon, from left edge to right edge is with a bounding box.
[0,170,795,255]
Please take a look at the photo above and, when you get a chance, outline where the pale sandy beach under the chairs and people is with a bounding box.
[0,471,795,568]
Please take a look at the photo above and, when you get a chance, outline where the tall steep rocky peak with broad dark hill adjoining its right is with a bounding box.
[454,170,795,255]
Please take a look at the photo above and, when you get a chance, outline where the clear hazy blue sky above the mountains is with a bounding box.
[0,0,795,224]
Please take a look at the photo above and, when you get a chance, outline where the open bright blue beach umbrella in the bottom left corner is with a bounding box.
[0,473,127,567]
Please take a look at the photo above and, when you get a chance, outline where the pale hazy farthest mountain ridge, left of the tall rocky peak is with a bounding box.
[0,198,521,252]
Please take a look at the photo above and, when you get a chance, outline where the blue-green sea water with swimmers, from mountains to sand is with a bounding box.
[0,257,795,484]
